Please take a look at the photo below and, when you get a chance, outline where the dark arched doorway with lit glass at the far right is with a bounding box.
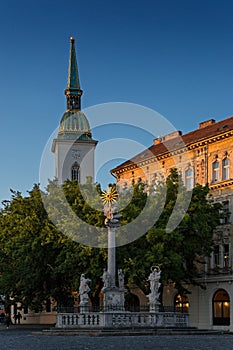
[212,289,230,326]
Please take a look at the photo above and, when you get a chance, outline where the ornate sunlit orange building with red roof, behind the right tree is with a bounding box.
[111,117,233,331]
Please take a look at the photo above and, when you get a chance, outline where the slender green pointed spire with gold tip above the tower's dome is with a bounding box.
[65,37,83,110]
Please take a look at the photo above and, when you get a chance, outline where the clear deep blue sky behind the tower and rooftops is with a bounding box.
[0,0,233,201]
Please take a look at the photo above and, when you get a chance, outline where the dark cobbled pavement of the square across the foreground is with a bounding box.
[0,326,233,350]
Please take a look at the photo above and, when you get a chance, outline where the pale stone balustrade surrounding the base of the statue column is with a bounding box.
[56,312,189,329]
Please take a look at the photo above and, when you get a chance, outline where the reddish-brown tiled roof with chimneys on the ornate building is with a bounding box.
[111,116,233,173]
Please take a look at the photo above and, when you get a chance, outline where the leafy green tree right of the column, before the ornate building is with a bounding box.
[117,169,221,294]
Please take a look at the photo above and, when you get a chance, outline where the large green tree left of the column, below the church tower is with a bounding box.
[0,182,106,310]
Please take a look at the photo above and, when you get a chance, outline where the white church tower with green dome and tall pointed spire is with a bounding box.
[52,37,97,184]
